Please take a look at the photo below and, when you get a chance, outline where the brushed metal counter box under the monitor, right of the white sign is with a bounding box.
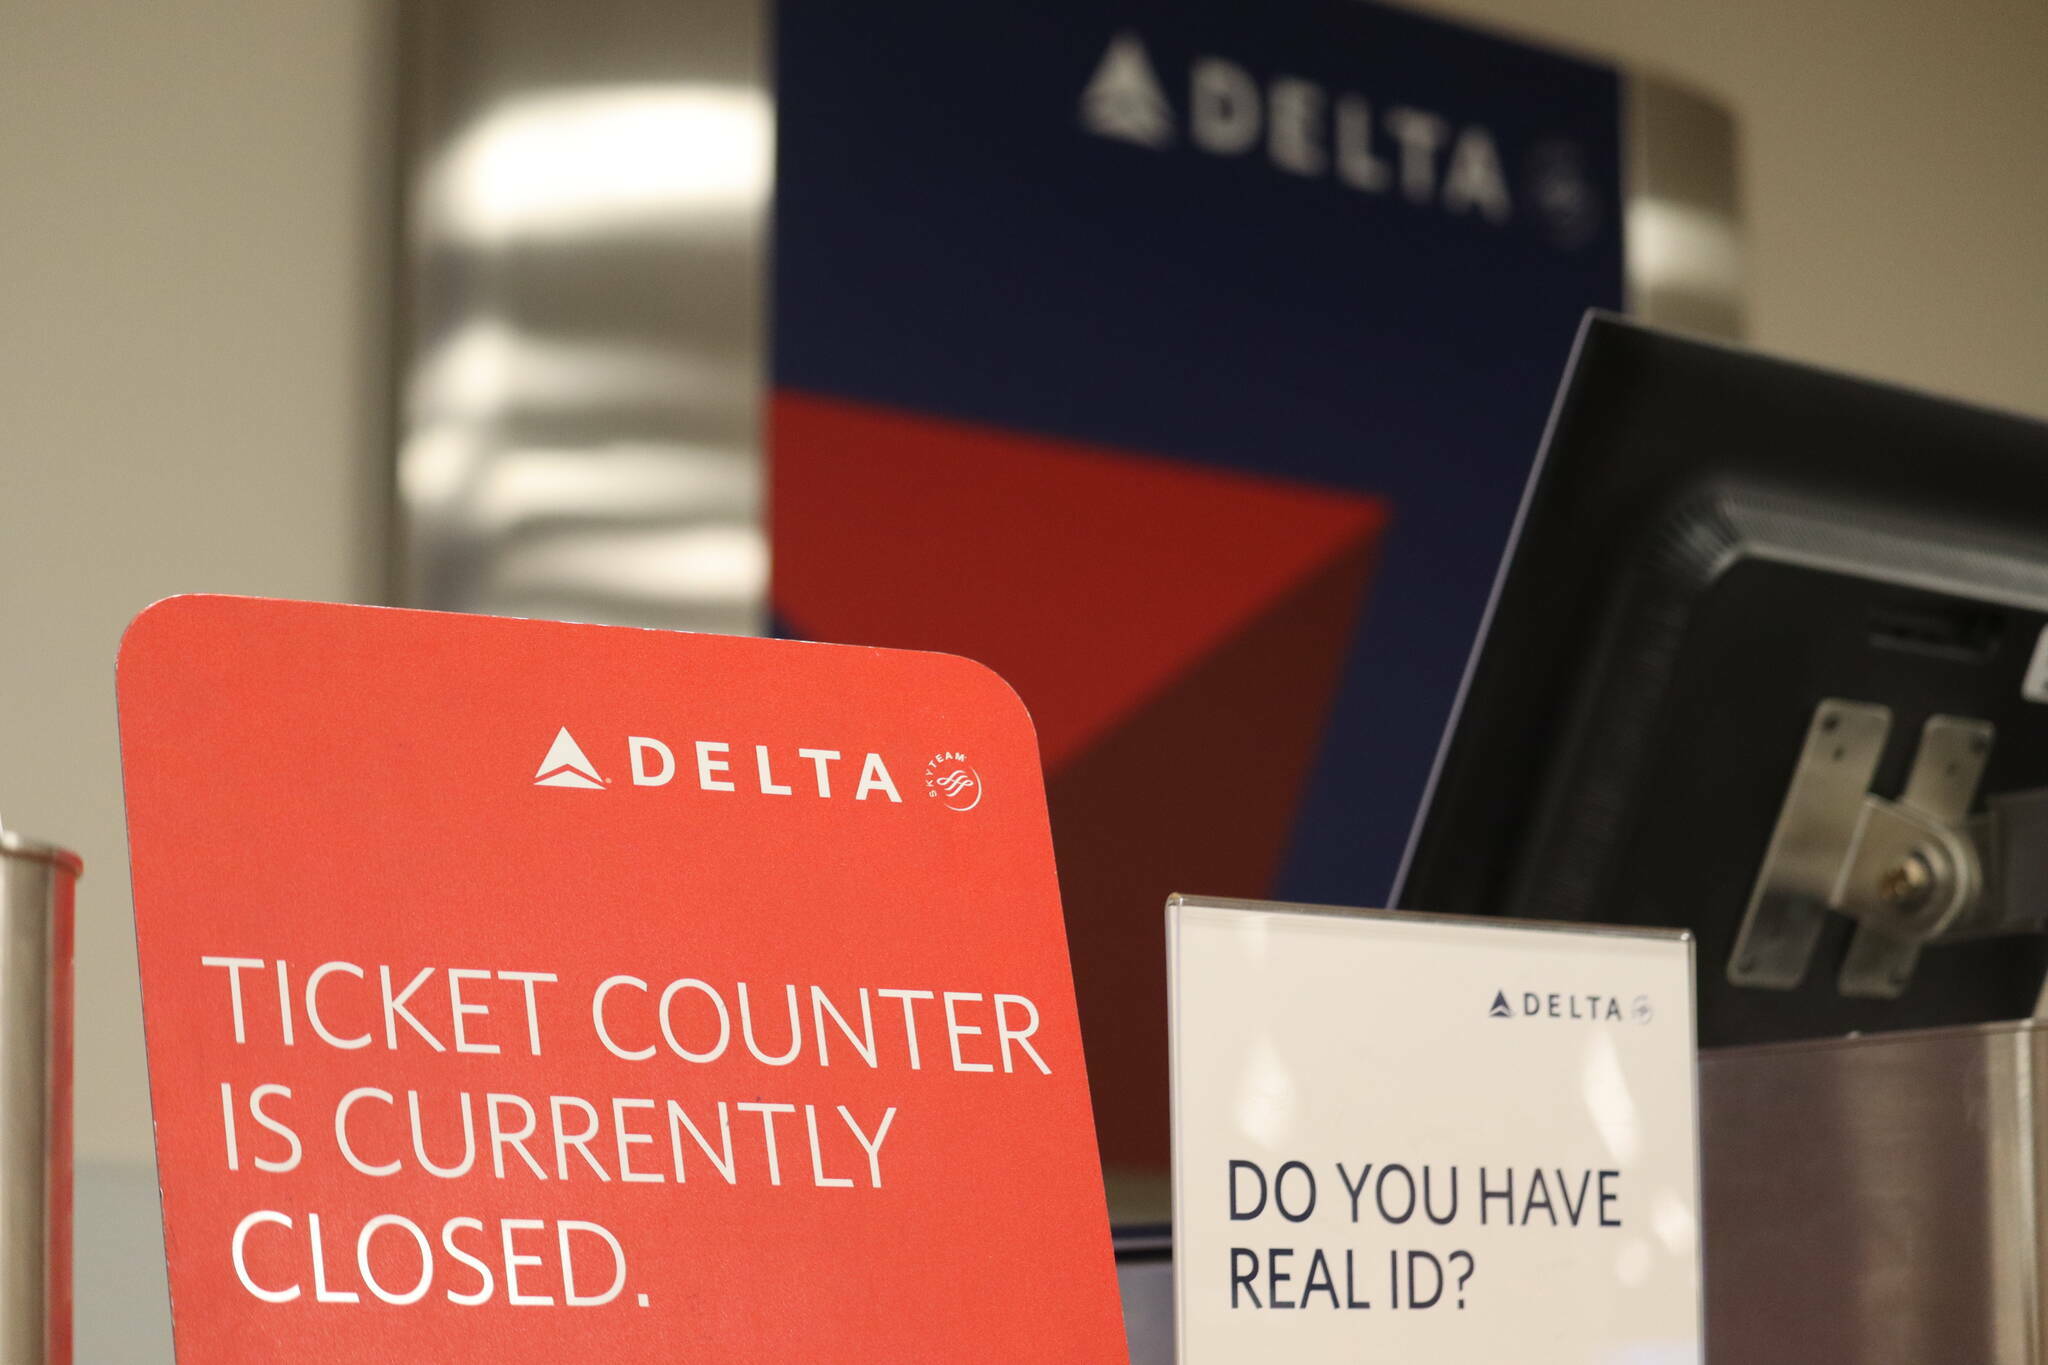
[1700,1021,2048,1365]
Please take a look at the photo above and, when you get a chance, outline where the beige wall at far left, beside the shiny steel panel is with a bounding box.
[0,0,389,1361]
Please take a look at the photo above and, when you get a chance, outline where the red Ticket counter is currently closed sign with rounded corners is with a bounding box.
[121,598,1124,1365]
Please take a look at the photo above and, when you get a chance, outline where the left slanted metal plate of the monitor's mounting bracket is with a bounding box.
[1729,698,1892,990]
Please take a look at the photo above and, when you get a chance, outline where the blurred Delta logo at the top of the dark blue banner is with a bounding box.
[1081,31,1599,246]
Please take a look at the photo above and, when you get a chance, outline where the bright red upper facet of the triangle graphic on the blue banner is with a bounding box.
[772,391,1386,769]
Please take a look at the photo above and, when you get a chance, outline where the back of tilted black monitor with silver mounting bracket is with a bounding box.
[1395,315,2048,1044]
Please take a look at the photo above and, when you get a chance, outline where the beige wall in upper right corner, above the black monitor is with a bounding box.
[1423,0,2048,415]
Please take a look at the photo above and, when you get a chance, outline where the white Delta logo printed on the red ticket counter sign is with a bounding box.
[532,726,981,812]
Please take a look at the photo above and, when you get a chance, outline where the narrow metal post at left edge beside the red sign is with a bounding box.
[0,833,78,1365]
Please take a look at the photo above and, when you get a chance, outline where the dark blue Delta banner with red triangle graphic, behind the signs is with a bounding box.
[770,0,1622,1164]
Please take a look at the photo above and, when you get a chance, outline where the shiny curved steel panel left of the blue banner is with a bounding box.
[397,0,774,634]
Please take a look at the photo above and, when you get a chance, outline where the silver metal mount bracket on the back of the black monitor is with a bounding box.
[1729,698,2048,999]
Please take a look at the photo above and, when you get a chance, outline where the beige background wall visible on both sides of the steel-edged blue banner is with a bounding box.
[0,0,2048,1361]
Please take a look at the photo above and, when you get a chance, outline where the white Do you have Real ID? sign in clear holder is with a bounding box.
[1167,896,1702,1365]
